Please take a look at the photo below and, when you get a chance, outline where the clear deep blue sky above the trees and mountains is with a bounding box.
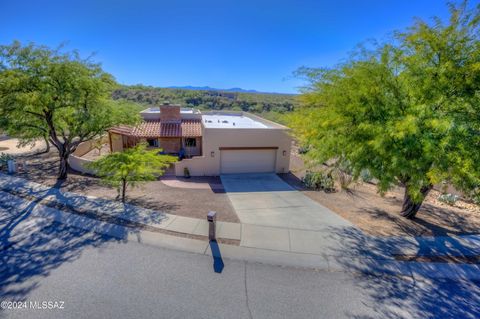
[0,0,454,93]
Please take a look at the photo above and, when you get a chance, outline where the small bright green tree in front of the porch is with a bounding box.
[88,144,177,202]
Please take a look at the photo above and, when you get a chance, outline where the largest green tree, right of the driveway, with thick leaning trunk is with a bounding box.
[291,2,480,218]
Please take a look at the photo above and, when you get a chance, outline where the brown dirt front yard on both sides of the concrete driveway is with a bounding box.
[7,147,480,236]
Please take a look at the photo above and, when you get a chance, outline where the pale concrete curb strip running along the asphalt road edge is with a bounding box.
[2,193,480,280]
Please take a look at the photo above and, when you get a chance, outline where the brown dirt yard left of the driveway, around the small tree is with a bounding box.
[8,151,239,223]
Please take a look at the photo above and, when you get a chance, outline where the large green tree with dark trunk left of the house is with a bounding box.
[0,42,138,179]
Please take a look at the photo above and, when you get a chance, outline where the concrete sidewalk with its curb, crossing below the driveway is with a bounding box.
[0,174,480,280]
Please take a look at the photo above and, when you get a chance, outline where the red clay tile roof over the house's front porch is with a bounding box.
[109,120,202,138]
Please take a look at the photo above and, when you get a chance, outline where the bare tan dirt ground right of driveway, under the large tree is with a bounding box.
[282,155,480,236]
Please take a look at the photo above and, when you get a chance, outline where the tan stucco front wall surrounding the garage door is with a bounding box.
[175,127,292,176]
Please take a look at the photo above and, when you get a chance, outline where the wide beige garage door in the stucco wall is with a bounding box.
[220,149,277,174]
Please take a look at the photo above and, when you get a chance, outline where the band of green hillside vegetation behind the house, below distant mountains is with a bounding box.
[113,85,297,121]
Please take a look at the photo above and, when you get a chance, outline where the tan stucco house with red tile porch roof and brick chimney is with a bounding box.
[108,103,291,176]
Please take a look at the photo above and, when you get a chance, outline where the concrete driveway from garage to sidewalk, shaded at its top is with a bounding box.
[221,174,352,230]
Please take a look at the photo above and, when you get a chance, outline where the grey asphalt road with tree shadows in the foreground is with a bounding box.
[0,209,480,319]
